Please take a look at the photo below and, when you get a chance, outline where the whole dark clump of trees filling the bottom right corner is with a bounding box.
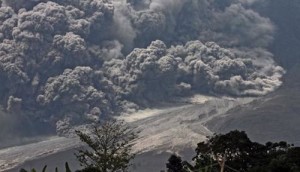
[166,131,300,172]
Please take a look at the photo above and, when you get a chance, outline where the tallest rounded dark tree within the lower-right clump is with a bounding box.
[194,131,261,171]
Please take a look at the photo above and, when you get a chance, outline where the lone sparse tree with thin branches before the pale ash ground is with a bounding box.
[75,120,137,172]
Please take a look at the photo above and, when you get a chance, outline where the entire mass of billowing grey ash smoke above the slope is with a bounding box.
[0,0,284,134]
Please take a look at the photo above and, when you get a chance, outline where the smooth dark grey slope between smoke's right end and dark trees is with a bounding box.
[207,66,300,145]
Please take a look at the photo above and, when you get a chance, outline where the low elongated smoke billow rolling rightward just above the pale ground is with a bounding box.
[105,41,284,101]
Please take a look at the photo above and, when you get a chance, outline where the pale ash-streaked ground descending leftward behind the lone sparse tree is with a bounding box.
[0,95,253,171]
